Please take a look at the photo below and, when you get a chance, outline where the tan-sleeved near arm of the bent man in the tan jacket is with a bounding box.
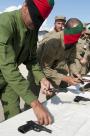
[37,37,64,85]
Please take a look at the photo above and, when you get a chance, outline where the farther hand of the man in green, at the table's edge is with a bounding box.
[40,78,53,96]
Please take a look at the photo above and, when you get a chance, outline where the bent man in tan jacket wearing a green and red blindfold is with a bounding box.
[37,18,83,91]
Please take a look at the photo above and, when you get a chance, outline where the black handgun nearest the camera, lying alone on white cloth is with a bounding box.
[18,120,52,133]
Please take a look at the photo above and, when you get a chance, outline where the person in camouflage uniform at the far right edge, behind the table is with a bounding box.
[70,24,90,76]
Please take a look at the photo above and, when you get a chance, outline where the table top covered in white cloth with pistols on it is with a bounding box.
[0,81,90,136]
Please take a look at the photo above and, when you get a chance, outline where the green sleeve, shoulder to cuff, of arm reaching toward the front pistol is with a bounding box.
[0,16,36,104]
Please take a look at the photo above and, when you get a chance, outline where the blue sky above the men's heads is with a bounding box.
[0,0,90,28]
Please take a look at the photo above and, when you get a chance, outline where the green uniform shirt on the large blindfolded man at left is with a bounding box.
[0,10,43,104]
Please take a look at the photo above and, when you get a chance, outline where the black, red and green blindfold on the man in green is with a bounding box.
[25,0,54,28]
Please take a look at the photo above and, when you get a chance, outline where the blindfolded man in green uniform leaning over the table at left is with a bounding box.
[0,0,54,125]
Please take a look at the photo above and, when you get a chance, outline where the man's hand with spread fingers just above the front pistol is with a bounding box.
[31,100,52,125]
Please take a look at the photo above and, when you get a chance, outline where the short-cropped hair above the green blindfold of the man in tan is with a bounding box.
[65,18,83,28]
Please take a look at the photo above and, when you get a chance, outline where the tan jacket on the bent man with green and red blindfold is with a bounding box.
[37,31,76,85]
